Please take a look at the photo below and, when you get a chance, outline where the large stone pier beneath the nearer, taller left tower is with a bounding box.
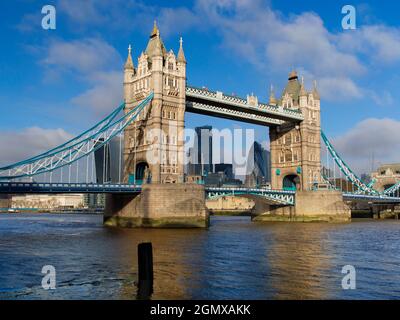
[104,183,209,228]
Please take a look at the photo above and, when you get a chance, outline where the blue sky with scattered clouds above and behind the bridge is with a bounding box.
[0,0,400,175]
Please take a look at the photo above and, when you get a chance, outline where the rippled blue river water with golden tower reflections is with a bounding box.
[0,214,400,299]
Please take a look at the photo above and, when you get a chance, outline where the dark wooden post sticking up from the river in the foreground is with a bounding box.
[137,242,153,299]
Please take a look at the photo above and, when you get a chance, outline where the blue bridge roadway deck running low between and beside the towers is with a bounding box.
[0,182,400,205]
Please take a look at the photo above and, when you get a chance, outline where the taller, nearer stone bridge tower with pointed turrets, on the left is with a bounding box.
[124,23,186,183]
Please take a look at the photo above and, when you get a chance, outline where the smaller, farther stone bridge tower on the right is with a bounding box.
[269,71,321,190]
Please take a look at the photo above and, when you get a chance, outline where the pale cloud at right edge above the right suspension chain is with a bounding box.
[332,118,400,172]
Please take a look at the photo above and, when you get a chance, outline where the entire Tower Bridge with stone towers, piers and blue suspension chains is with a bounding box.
[0,24,400,227]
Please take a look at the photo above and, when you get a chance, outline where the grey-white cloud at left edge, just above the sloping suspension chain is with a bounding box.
[0,127,72,166]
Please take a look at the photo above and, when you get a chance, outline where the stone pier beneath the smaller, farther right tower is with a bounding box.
[253,190,351,222]
